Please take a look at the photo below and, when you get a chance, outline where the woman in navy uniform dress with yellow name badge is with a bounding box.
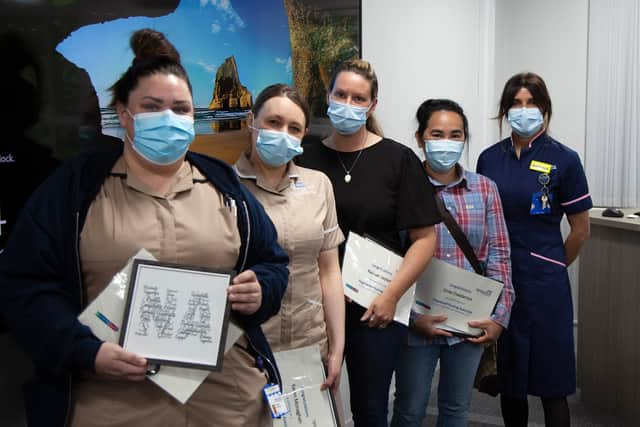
[477,73,592,426]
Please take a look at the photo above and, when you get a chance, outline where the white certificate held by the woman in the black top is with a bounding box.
[342,232,416,325]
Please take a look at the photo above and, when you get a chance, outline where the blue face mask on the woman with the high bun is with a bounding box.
[127,110,196,166]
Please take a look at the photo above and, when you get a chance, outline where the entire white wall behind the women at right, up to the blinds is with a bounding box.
[362,0,589,160]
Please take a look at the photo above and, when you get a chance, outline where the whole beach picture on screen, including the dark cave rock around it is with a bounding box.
[0,0,360,159]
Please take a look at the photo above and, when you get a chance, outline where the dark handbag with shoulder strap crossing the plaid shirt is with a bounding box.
[434,194,500,397]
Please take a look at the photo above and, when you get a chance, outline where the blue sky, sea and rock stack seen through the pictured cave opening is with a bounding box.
[57,0,292,137]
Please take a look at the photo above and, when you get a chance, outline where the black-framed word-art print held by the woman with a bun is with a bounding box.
[120,259,233,371]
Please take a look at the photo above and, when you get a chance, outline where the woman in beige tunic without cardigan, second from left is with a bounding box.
[235,84,344,408]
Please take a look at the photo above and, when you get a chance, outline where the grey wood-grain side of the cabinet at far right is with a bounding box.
[578,224,640,425]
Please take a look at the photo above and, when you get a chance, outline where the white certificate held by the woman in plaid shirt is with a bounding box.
[413,258,503,336]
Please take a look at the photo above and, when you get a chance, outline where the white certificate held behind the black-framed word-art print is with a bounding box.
[78,249,244,403]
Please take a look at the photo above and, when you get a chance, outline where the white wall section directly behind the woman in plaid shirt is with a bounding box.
[362,0,494,168]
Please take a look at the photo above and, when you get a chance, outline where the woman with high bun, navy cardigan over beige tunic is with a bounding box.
[0,30,288,426]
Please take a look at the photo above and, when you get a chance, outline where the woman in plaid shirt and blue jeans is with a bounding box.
[391,99,514,427]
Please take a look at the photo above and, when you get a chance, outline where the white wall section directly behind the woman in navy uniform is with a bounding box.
[493,0,589,159]
